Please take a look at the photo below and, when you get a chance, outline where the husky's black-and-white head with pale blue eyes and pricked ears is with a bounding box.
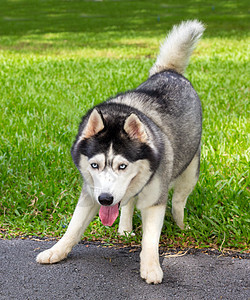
[72,106,161,211]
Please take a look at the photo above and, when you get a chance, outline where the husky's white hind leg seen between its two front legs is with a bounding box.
[118,198,135,235]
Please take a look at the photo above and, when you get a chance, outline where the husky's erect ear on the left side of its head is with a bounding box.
[82,109,104,139]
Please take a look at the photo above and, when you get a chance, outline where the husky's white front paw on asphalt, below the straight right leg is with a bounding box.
[141,263,163,284]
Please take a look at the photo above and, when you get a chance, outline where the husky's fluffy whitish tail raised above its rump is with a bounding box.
[150,20,205,76]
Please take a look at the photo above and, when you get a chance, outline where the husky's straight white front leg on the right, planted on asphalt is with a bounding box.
[140,205,166,284]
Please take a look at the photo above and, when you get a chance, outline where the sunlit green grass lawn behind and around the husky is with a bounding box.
[0,0,250,251]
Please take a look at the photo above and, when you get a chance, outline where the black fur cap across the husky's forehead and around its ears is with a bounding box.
[71,102,162,172]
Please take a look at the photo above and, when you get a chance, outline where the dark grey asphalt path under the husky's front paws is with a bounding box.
[0,239,250,300]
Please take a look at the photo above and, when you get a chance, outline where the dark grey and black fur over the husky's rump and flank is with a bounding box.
[135,70,202,178]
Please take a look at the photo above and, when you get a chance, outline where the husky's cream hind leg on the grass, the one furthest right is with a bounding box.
[172,152,200,229]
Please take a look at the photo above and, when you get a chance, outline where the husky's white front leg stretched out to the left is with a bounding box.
[36,188,100,264]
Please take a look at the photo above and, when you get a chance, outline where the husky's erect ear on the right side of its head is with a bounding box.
[124,114,148,143]
